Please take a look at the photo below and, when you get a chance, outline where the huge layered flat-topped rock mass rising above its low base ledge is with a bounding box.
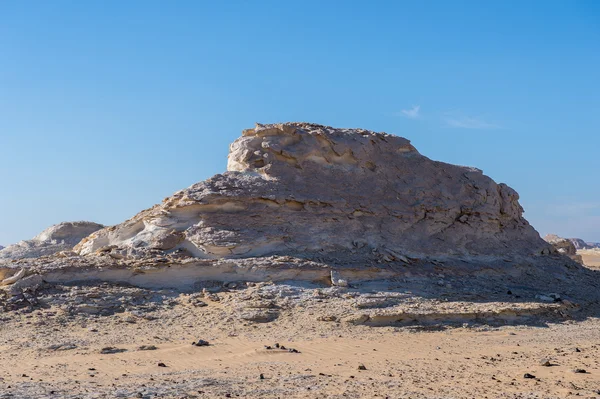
[75,123,552,261]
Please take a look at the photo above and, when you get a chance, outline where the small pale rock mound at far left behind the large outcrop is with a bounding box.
[0,222,104,260]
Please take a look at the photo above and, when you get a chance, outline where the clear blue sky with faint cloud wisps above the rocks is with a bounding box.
[0,0,600,245]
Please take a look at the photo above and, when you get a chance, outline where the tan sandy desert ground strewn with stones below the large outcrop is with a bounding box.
[0,276,600,399]
